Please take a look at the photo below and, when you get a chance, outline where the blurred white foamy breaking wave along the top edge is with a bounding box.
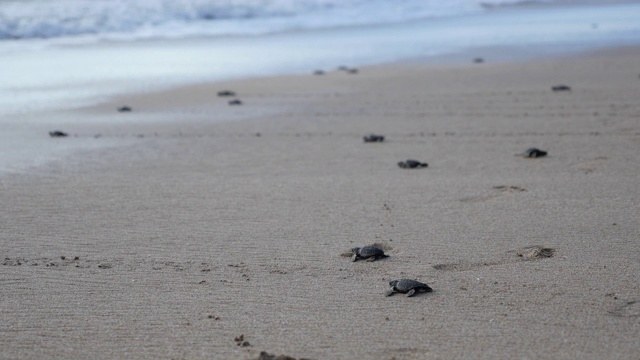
[0,0,551,40]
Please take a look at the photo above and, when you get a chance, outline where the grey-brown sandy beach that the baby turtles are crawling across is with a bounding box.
[0,48,640,359]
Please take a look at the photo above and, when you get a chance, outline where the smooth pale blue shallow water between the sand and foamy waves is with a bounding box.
[0,4,640,172]
